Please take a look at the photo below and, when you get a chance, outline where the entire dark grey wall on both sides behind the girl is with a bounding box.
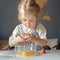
[0,0,60,41]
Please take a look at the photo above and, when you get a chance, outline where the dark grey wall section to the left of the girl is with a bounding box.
[0,0,18,40]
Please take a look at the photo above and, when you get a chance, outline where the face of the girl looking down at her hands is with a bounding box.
[22,15,36,29]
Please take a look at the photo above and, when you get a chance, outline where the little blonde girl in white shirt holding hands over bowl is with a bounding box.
[9,0,47,47]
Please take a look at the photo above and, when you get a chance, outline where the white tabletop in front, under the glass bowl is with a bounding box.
[0,50,60,60]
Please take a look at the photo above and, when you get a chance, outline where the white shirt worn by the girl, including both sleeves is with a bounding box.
[9,23,46,40]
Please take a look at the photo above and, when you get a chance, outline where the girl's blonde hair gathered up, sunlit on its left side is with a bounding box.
[18,0,40,20]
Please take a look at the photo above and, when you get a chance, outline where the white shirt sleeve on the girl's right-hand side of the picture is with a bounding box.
[37,23,47,39]
